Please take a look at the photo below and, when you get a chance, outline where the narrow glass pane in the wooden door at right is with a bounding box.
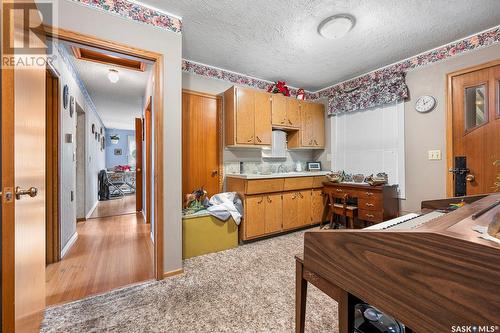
[465,85,488,130]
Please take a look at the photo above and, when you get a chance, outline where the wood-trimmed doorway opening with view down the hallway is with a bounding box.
[46,31,163,306]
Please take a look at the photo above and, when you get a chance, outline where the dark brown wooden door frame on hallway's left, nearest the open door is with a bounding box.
[45,66,61,264]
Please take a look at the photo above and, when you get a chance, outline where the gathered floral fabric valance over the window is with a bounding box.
[328,72,408,115]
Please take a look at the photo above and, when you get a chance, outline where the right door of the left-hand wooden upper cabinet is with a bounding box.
[254,92,273,145]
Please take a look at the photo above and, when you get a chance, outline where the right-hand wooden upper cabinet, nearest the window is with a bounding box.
[288,102,325,149]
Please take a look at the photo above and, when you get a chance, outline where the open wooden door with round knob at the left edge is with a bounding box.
[1,5,46,332]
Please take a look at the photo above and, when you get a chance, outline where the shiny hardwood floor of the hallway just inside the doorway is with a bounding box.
[46,213,154,306]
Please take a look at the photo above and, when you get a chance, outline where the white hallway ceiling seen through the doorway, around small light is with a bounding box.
[69,43,151,130]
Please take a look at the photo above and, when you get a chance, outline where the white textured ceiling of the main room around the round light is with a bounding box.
[141,0,500,91]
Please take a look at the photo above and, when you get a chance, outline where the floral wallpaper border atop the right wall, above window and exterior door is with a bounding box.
[312,26,500,115]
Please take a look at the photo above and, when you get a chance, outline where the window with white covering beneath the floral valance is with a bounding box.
[332,102,405,199]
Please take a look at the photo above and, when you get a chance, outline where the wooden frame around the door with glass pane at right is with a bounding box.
[446,59,500,198]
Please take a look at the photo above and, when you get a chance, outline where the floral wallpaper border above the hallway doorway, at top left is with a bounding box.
[71,0,182,33]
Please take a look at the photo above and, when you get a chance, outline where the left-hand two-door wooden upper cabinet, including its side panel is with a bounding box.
[224,87,272,146]
